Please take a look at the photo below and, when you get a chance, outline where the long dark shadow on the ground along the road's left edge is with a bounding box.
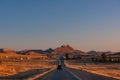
[0,69,49,80]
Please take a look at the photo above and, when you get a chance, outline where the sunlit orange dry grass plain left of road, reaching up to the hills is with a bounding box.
[0,53,55,76]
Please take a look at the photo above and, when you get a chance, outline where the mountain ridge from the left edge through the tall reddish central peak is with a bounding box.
[0,45,86,55]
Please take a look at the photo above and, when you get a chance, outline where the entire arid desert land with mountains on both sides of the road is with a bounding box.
[0,45,120,80]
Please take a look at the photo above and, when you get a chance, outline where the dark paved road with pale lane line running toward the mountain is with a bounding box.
[36,68,116,80]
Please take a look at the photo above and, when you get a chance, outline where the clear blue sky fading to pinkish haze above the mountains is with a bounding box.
[0,0,120,51]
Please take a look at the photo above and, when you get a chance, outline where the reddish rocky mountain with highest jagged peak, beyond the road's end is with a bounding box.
[53,45,85,55]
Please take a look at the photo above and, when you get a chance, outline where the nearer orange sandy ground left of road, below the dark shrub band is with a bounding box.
[0,60,55,76]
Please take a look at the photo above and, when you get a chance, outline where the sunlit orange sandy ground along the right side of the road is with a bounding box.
[65,61,120,80]
